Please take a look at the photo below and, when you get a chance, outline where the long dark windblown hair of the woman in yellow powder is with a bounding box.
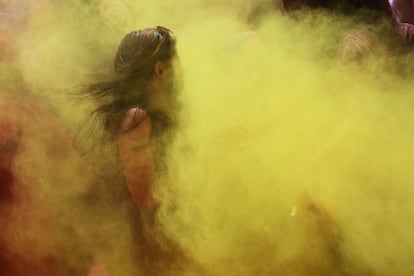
[75,26,176,151]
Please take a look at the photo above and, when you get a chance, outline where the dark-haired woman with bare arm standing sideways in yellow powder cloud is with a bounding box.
[81,27,183,275]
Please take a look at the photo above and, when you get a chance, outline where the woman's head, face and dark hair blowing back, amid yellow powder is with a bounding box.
[87,26,176,138]
